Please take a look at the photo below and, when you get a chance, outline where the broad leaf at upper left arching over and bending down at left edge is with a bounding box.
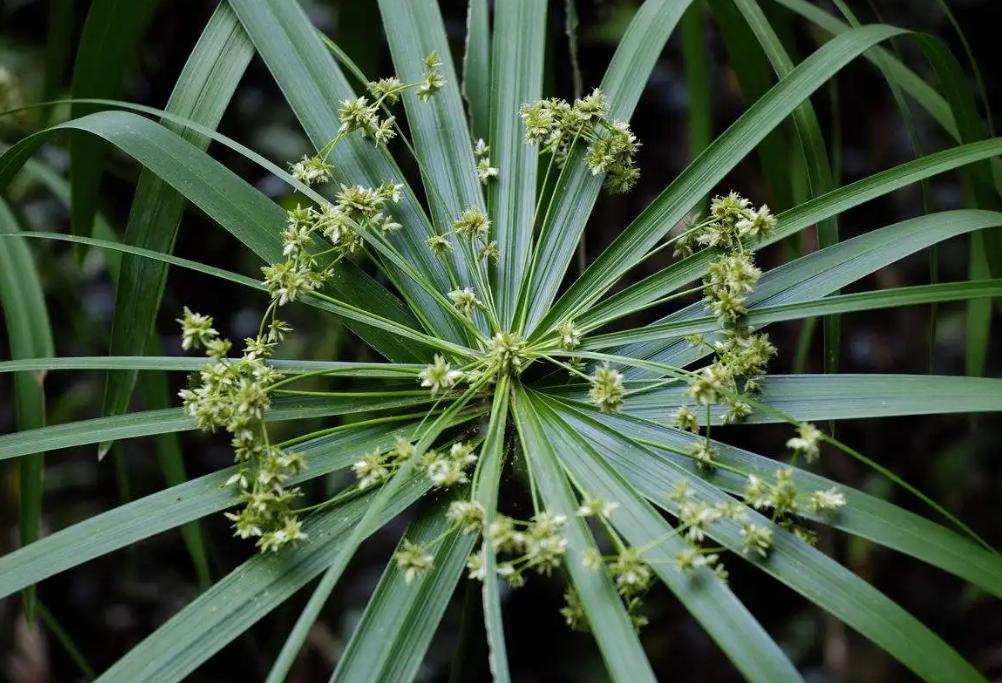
[0,111,430,361]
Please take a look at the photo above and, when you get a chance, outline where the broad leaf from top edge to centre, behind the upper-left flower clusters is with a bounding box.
[229,0,464,346]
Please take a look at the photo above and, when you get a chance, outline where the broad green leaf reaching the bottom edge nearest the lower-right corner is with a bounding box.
[545,398,984,682]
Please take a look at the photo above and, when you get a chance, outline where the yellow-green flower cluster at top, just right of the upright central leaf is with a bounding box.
[522,88,640,193]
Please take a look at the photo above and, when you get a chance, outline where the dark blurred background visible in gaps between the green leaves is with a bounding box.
[0,0,1002,683]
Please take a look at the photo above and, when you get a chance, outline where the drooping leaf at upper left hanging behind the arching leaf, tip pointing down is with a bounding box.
[102,3,254,452]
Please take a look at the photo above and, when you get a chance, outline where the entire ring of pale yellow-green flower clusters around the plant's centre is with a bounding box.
[178,53,846,629]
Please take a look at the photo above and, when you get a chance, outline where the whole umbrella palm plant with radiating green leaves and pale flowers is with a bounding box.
[0,0,1002,682]
